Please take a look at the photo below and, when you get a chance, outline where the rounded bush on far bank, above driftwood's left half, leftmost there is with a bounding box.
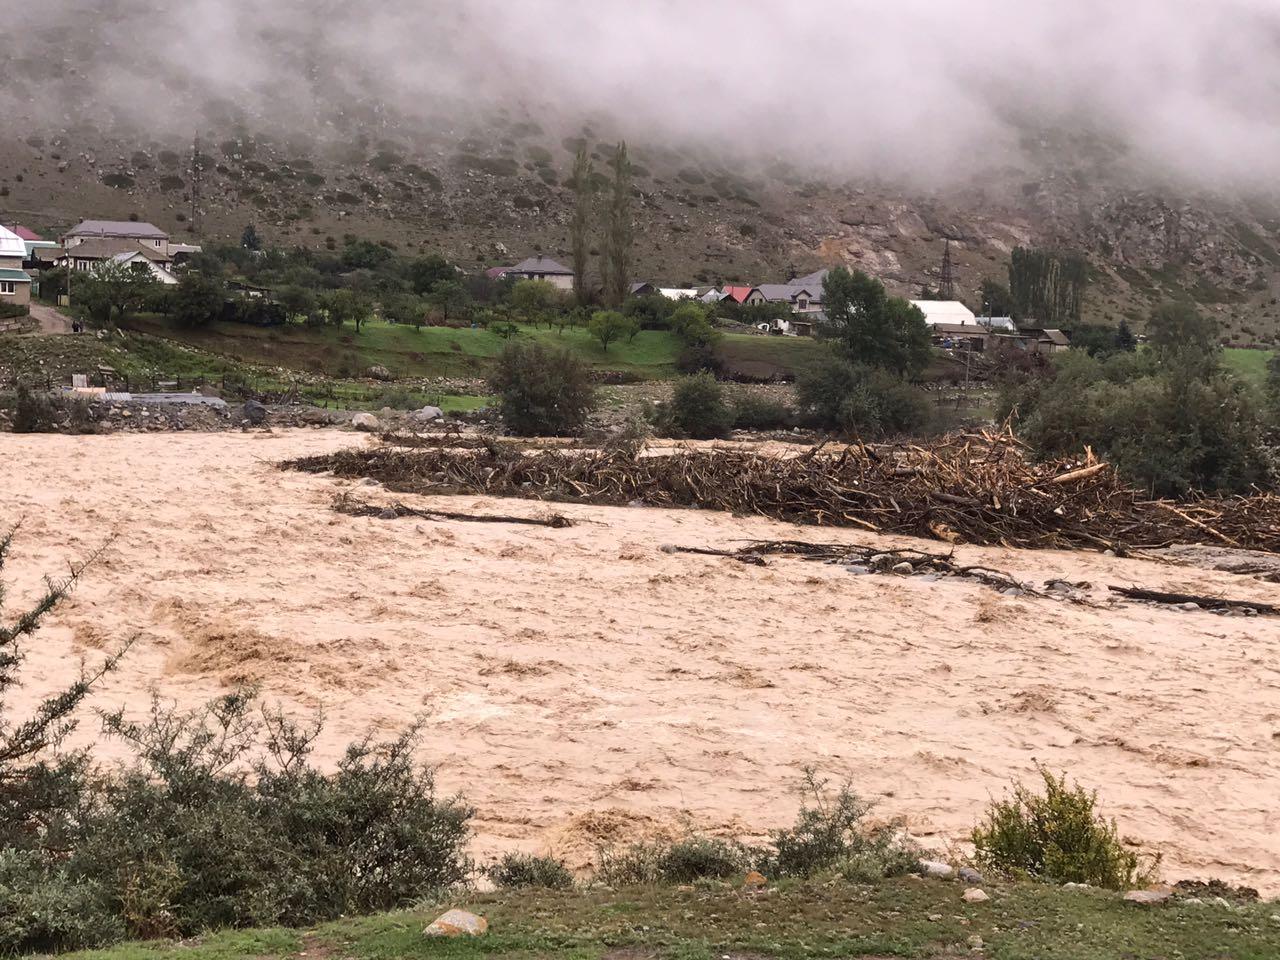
[489,342,596,436]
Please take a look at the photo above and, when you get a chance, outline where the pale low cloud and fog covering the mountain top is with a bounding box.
[10,0,1280,186]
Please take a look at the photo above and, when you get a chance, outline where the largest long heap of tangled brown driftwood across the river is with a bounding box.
[285,434,1280,554]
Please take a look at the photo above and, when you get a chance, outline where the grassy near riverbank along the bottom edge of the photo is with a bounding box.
[62,879,1280,960]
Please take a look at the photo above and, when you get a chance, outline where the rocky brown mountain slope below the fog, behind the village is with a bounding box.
[0,116,1280,343]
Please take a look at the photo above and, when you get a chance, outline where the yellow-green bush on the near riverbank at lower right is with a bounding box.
[972,765,1158,890]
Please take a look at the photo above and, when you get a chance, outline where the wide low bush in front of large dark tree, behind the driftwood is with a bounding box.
[796,356,932,439]
